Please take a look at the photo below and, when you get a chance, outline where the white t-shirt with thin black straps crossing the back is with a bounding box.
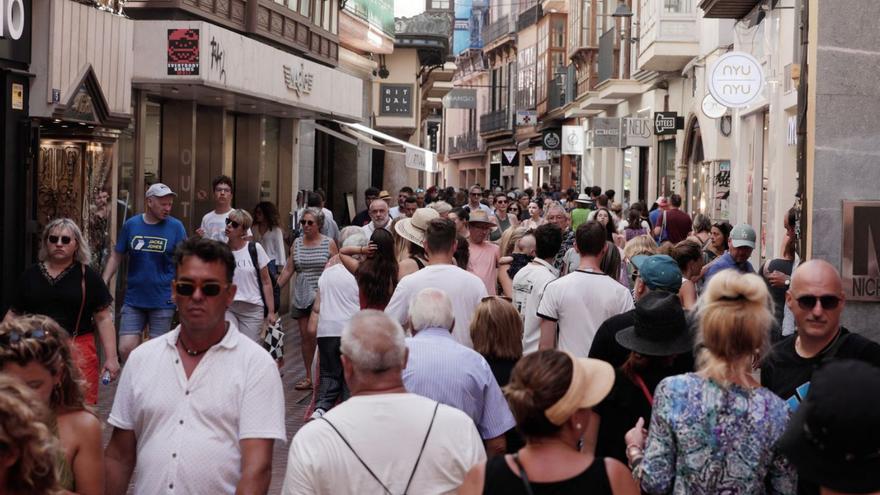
[276,396,486,495]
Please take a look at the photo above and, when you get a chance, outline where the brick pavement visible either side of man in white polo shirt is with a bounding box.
[98,317,311,495]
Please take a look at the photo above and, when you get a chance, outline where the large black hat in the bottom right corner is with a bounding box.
[779,359,880,493]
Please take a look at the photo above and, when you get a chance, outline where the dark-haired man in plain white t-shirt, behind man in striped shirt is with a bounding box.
[385,218,488,348]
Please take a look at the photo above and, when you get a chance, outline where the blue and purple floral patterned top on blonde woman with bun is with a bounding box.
[641,373,797,495]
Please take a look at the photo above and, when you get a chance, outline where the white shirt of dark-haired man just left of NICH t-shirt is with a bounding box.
[513,258,559,354]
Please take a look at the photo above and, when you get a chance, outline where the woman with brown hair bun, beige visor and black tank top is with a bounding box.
[459,350,638,495]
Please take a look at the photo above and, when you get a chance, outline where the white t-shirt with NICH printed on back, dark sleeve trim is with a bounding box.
[538,270,635,358]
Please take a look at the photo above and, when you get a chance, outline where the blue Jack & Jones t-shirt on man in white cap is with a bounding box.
[116,215,186,309]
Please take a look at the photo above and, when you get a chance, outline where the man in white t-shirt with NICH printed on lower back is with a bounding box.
[538,221,635,357]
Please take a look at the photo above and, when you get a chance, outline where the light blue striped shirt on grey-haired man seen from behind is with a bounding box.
[403,328,516,440]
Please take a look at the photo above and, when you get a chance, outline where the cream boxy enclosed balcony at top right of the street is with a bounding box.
[638,0,700,72]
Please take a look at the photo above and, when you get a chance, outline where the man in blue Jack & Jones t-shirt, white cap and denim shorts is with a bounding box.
[104,184,186,361]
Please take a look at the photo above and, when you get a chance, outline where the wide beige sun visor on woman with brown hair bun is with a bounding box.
[544,353,614,426]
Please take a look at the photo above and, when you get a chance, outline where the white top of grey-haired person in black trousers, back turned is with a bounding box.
[318,263,361,337]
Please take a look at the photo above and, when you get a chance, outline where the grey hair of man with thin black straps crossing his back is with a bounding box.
[340,309,406,373]
